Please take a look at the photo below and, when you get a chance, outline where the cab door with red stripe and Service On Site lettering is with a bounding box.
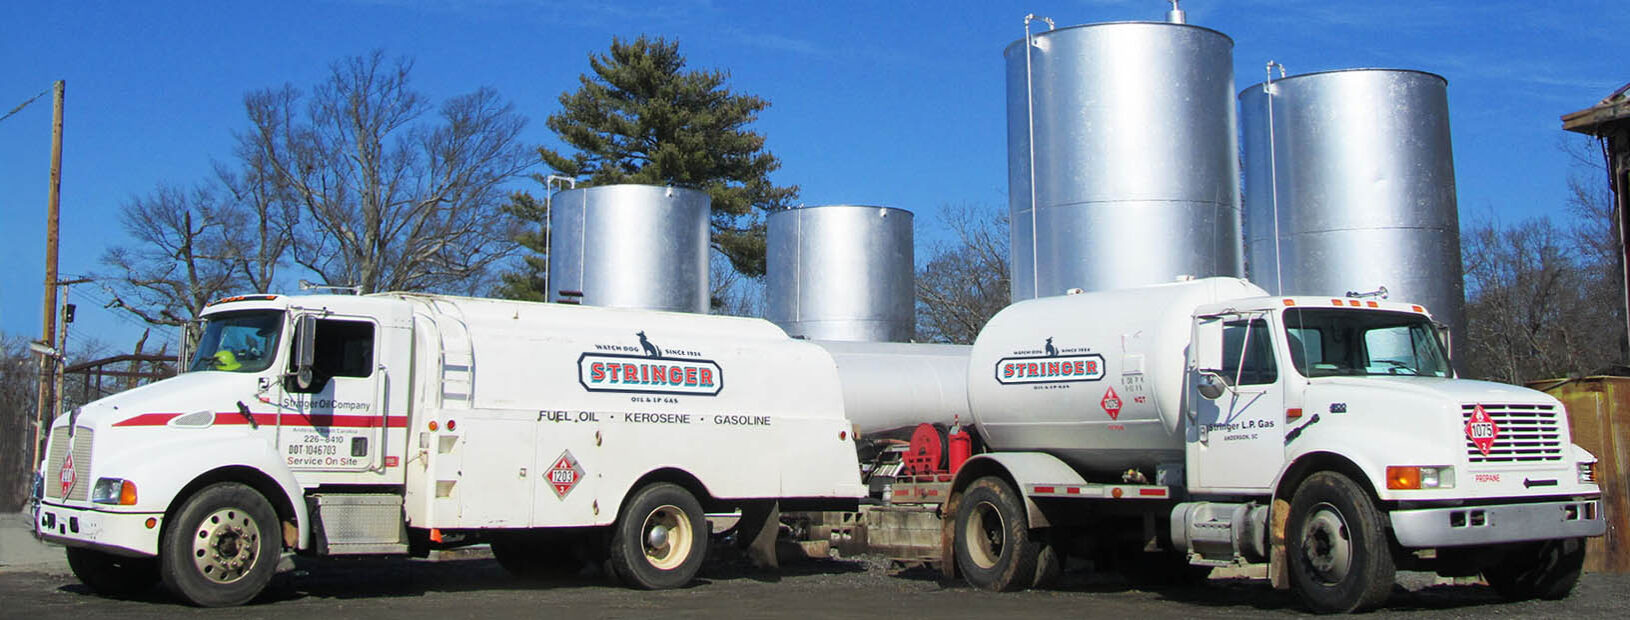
[277,313,384,472]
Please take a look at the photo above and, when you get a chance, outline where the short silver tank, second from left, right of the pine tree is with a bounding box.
[764,204,916,343]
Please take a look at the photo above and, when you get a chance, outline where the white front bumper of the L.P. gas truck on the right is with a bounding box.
[1389,498,1607,548]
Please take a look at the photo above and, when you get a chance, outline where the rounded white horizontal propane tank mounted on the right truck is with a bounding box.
[968,277,1267,478]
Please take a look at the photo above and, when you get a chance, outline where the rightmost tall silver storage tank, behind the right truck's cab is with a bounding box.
[1239,69,1465,354]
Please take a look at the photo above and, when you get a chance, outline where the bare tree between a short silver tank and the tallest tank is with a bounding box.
[916,204,1011,344]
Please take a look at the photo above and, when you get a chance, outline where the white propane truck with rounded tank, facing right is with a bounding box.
[838,277,1606,612]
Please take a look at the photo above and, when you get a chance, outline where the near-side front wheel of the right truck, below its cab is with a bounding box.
[1284,472,1397,613]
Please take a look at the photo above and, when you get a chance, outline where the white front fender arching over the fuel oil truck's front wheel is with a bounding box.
[96,432,311,548]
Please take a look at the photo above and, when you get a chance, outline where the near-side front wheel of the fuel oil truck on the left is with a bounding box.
[158,483,282,607]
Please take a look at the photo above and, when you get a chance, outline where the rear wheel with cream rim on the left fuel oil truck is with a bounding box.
[611,483,707,591]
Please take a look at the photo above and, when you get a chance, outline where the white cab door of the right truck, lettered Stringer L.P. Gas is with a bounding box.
[1187,313,1288,489]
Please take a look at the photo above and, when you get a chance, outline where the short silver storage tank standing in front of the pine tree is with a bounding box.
[549,184,711,313]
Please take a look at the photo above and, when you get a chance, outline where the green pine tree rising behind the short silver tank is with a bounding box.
[499,36,799,299]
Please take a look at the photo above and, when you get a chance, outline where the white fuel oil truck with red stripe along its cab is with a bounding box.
[36,294,864,605]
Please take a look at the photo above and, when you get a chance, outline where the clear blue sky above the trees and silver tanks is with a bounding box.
[0,0,1630,355]
